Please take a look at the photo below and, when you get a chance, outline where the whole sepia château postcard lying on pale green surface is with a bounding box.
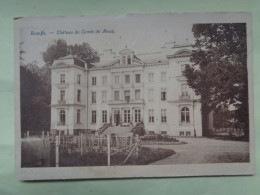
[15,13,255,180]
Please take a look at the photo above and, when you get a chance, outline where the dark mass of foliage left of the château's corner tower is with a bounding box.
[20,66,50,135]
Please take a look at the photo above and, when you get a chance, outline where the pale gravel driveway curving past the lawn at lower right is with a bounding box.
[147,138,249,165]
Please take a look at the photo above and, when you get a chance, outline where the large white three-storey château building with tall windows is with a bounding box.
[51,44,202,136]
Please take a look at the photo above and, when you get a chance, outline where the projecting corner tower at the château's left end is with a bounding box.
[51,55,87,134]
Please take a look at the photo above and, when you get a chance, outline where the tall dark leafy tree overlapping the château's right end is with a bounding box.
[184,23,249,137]
